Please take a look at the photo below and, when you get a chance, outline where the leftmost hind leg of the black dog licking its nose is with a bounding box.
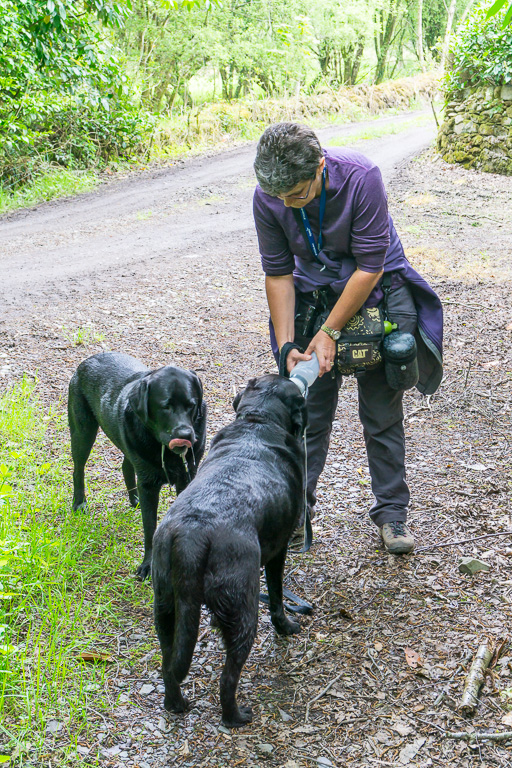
[68,376,98,510]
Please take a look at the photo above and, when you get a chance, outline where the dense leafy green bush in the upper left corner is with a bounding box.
[0,0,152,185]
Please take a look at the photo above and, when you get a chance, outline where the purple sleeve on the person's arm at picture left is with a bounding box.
[253,187,295,277]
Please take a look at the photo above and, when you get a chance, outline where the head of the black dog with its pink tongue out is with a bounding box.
[129,365,204,453]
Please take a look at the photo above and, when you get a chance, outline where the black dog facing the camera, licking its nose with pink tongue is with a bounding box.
[68,352,206,579]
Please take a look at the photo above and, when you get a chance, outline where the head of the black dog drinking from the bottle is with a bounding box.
[233,373,308,437]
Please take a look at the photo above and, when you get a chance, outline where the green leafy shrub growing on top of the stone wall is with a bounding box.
[446,3,512,93]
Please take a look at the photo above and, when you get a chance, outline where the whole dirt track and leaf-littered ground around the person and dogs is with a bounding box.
[0,118,512,768]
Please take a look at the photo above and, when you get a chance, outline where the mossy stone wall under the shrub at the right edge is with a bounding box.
[437,83,512,176]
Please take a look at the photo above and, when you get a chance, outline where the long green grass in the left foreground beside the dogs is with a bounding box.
[0,380,151,766]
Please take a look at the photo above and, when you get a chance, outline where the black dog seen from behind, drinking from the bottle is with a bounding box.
[152,375,307,728]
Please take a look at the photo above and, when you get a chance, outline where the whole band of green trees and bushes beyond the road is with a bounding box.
[0,0,488,201]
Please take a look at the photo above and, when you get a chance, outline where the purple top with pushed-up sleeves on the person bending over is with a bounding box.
[253,148,404,304]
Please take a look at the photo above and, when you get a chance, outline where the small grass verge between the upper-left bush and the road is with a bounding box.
[0,169,99,213]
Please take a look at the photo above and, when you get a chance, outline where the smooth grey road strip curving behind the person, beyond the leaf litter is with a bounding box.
[0,113,434,318]
